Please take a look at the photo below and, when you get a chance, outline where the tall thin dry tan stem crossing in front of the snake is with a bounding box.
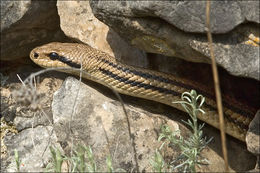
[206,0,229,172]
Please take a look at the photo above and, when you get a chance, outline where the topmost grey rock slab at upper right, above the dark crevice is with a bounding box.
[91,1,260,33]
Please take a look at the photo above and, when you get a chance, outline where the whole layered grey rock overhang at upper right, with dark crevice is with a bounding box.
[91,1,259,80]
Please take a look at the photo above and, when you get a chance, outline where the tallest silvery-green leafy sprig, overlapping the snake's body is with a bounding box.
[153,90,212,172]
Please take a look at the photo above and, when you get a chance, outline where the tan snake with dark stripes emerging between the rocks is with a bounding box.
[30,42,255,141]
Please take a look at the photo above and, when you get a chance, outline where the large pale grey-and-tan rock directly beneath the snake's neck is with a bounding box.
[52,77,254,172]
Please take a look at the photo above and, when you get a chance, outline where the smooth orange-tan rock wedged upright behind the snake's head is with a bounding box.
[57,0,147,67]
